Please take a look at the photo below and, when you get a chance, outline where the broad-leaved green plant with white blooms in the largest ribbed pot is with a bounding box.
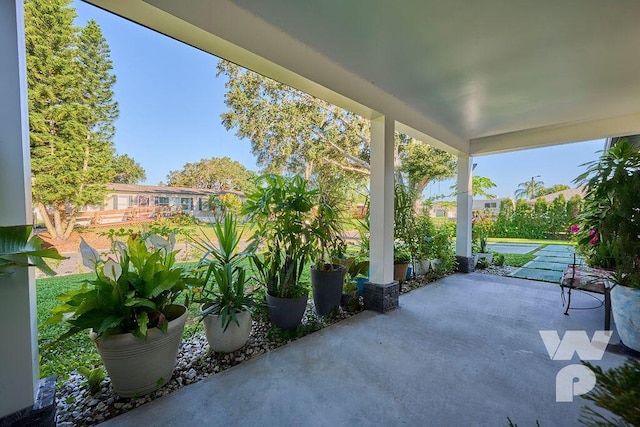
[46,235,189,339]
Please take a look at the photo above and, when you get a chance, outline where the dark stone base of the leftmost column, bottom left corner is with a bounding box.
[0,377,56,427]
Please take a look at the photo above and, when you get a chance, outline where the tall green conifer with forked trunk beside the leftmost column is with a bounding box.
[25,0,118,239]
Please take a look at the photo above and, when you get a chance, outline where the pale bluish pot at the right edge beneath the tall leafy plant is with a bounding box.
[611,285,640,351]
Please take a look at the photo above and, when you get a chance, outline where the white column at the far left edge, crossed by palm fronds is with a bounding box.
[0,0,39,418]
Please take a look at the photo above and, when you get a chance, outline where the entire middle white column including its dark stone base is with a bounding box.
[364,116,399,313]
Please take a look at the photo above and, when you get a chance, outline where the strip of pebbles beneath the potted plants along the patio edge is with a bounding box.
[56,276,448,427]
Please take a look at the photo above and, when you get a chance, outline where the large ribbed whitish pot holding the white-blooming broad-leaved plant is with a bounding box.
[90,306,187,397]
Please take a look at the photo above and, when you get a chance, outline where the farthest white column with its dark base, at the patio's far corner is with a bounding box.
[456,156,475,273]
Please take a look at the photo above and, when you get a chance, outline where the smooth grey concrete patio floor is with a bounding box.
[103,273,625,427]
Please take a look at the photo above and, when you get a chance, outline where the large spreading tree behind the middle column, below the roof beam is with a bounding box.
[218,61,455,207]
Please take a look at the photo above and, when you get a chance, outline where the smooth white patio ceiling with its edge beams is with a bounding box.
[82,0,640,155]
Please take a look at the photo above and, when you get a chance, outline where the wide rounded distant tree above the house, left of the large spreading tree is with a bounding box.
[167,157,256,192]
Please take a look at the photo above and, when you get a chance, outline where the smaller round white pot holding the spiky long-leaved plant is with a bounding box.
[203,311,251,353]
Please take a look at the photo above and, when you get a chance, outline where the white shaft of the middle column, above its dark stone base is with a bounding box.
[369,117,395,284]
